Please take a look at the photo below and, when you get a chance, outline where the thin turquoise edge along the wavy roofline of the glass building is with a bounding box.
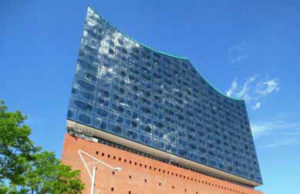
[87,5,244,101]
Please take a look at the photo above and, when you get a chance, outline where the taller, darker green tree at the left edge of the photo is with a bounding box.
[0,100,39,184]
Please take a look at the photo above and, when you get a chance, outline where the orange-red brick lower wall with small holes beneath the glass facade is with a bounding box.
[62,134,262,194]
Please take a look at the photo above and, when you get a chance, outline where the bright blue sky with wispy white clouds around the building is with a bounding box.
[0,0,300,194]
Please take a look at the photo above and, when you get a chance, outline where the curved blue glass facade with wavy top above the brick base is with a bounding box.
[67,8,262,183]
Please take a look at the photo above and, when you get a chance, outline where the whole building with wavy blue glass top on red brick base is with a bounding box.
[62,8,262,194]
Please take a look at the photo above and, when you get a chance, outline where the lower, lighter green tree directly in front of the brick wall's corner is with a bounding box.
[23,152,83,193]
